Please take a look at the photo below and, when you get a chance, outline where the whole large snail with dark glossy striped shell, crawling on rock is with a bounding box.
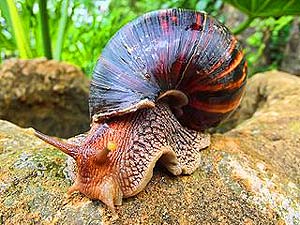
[35,9,247,210]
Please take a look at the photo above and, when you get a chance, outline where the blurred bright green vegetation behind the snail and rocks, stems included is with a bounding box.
[0,0,300,75]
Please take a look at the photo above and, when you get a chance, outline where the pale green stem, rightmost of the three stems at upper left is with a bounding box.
[54,0,69,60]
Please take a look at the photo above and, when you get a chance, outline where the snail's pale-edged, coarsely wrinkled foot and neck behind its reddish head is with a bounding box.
[120,105,209,196]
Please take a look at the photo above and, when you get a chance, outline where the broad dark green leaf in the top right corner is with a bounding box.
[225,0,300,17]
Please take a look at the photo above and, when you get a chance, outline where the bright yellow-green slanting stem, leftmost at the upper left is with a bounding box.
[6,0,32,59]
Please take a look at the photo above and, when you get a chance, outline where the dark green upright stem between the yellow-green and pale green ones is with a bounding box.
[39,0,52,59]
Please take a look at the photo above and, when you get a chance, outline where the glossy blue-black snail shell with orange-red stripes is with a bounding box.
[89,9,247,130]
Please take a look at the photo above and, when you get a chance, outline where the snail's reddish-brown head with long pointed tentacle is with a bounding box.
[35,123,123,210]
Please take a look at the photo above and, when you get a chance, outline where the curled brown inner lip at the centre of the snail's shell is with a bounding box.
[157,89,189,117]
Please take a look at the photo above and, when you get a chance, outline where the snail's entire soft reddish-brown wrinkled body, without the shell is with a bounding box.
[36,103,210,209]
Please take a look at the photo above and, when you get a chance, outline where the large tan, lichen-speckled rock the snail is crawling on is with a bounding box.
[0,71,300,225]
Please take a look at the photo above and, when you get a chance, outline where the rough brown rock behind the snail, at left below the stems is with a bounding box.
[0,59,89,137]
